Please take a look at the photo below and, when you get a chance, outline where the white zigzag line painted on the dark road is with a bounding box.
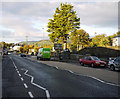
[24,69,50,99]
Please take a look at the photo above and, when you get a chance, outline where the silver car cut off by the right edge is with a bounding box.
[108,57,120,70]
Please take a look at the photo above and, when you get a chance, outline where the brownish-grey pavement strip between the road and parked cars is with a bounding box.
[29,56,120,85]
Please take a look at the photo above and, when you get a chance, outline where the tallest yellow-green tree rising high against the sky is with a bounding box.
[47,3,80,48]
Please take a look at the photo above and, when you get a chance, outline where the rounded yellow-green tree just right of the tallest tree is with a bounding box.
[70,29,90,50]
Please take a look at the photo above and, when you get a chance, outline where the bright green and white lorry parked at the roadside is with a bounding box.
[37,48,51,60]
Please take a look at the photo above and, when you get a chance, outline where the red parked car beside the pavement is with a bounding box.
[79,56,106,67]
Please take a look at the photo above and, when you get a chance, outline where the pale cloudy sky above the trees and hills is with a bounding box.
[0,0,118,42]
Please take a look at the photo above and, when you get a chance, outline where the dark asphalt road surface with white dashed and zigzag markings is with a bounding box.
[2,55,119,99]
